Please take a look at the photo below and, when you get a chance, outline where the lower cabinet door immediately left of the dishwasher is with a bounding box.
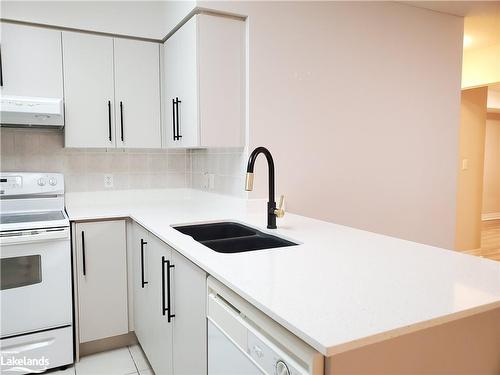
[172,250,207,375]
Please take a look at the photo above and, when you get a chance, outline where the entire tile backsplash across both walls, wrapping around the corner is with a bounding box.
[0,128,246,197]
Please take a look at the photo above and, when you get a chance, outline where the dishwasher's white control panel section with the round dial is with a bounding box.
[247,330,307,375]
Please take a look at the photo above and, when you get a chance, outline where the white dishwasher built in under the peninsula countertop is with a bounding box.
[207,277,324,375]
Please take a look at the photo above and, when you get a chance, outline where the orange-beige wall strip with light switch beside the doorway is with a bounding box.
[456,87,488,250]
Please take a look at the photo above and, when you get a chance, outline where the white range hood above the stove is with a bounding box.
[0,95,64,128]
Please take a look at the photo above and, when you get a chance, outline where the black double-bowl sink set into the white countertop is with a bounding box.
[173,222,297,253]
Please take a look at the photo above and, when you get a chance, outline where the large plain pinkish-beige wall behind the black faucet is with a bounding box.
[199,1,463,248]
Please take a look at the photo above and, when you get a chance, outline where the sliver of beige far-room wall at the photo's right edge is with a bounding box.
[483,113,500,218]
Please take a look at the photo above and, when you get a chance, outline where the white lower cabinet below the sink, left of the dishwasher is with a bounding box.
[132,224,207,375]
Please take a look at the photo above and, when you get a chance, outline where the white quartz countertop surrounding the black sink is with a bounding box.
[66,189,500,356]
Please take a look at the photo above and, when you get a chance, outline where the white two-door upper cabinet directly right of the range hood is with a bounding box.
[62,32,161,148]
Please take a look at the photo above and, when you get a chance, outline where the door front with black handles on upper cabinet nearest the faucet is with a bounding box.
[162,16,199,148]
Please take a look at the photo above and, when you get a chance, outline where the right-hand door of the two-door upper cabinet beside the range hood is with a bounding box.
[114,38,161,148]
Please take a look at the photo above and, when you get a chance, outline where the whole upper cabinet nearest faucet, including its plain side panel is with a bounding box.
[162,14,245,148]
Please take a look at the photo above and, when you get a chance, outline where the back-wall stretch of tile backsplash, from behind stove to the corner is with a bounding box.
[0,128,191,191]
